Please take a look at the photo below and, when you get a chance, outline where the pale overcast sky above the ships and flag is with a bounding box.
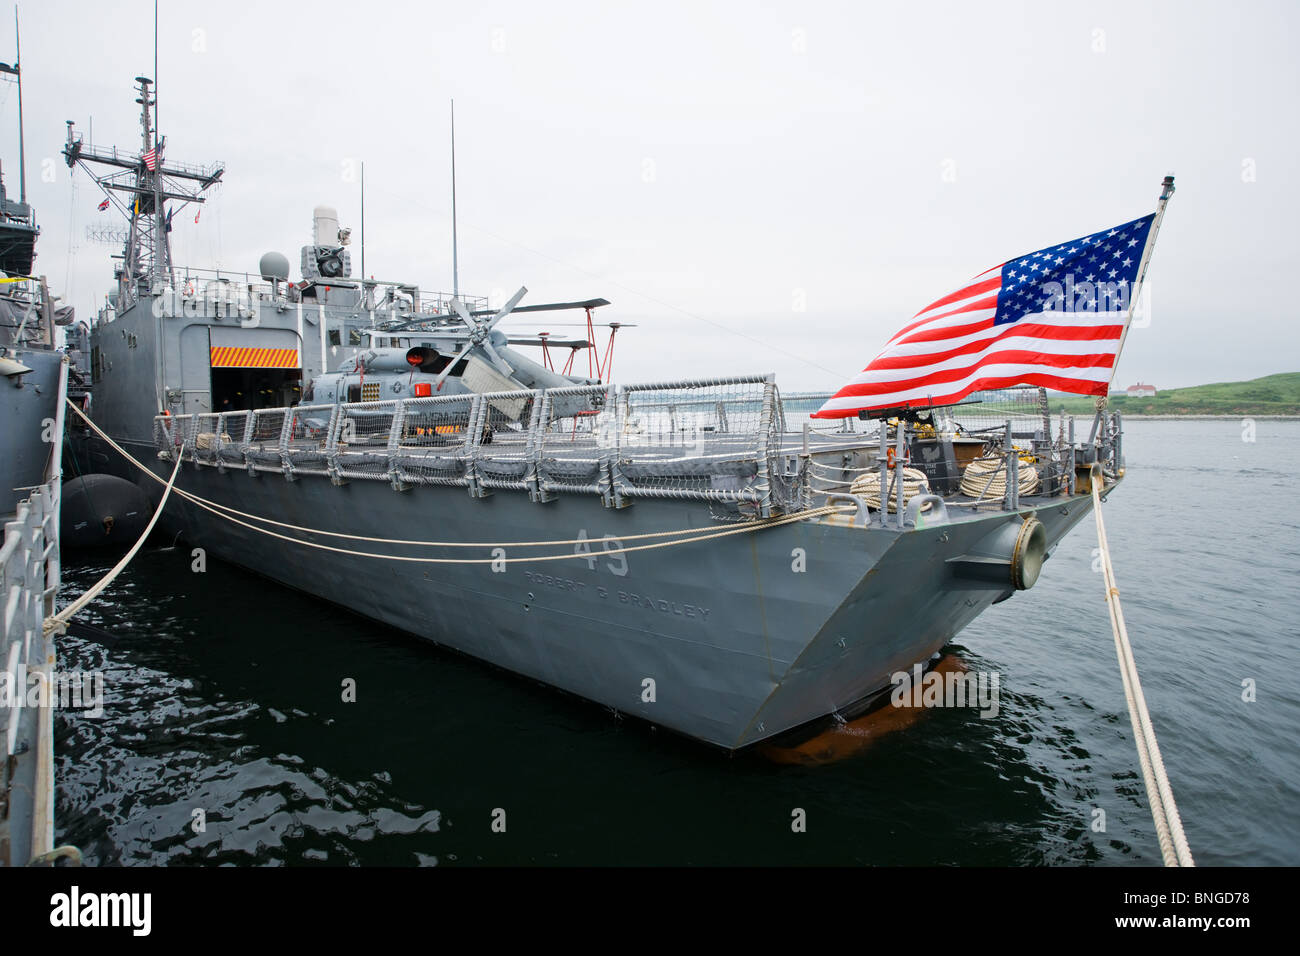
[0,0,1300,392]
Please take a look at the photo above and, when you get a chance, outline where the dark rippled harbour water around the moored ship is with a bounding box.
[56,421,1300,865]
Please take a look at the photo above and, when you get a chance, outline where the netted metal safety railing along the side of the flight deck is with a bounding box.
[155,376,780,515]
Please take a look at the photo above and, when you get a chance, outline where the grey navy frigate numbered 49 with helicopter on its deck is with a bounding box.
[64,78,1159,750]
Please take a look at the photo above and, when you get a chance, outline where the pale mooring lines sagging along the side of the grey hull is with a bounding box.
[69,402,854,564]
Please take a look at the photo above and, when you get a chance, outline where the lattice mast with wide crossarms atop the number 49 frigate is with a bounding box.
[64,77,225,311]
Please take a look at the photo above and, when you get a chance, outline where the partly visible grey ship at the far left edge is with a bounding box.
[0,26,74,866]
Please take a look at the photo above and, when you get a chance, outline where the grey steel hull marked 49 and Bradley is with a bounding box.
[104,444,1091,749]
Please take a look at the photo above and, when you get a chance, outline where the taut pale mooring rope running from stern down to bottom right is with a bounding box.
[1092,464,1196,866]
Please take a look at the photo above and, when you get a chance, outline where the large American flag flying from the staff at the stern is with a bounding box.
[813,213,1156,419]
